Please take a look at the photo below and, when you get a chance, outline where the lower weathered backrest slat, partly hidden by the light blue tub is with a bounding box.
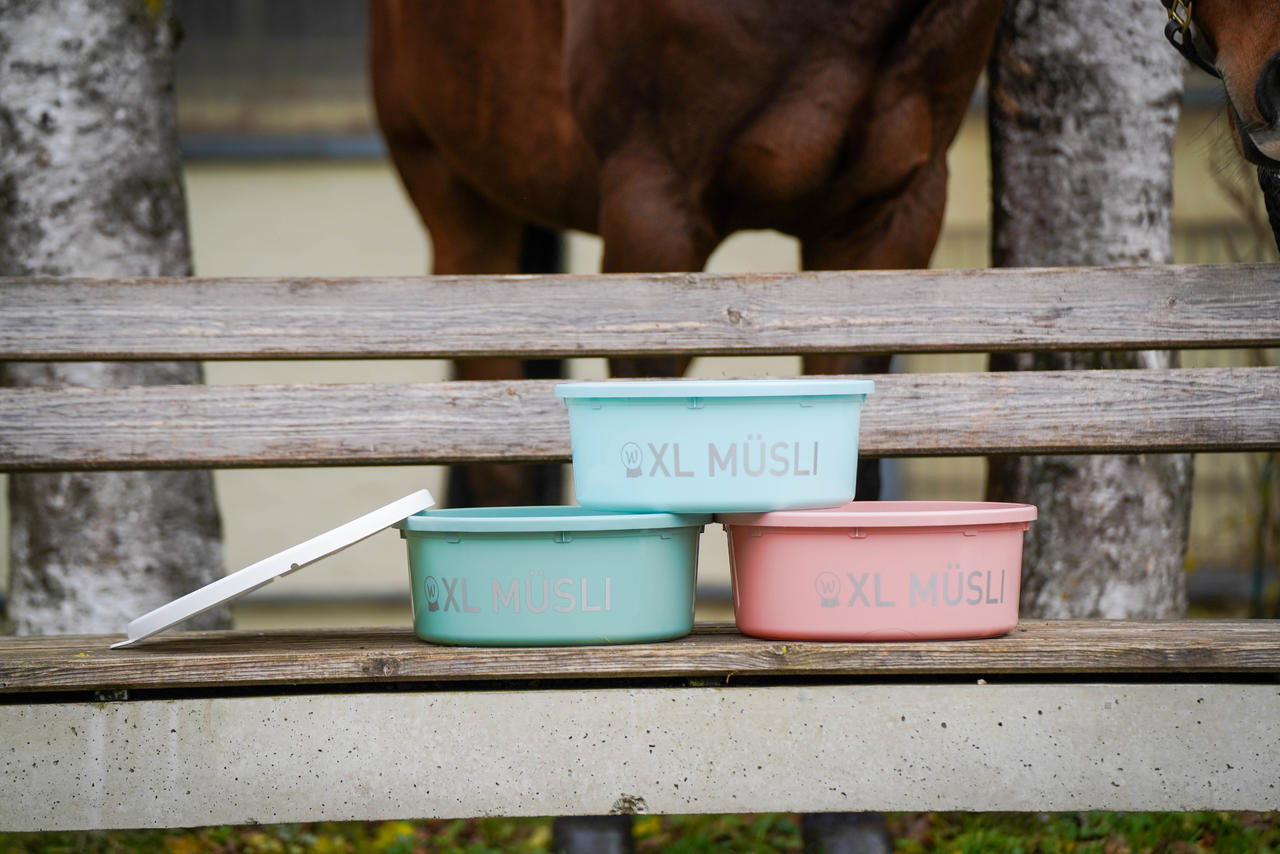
[0,367,1280,471]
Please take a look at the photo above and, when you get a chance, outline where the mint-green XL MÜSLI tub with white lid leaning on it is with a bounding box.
[396,507,710,647]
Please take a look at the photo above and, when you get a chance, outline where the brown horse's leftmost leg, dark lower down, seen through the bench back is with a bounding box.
[387,133,563,507]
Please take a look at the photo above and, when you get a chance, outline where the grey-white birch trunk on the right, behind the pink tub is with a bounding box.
[988,0,1192,617]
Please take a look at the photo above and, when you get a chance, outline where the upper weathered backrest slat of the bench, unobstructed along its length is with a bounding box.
[0,264,1280,360]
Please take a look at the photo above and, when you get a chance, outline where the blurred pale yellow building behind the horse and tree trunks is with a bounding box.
[0,0,1280,629]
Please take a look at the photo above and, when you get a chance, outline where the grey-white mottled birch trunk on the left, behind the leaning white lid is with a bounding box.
[0,0,228,634]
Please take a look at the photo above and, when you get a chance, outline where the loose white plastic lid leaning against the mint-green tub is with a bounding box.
[111,489,435,649]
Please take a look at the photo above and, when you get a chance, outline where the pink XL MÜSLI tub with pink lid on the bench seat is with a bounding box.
[716,501,1036,640]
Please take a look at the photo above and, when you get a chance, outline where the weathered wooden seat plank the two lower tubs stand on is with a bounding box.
[0,620,1280,693]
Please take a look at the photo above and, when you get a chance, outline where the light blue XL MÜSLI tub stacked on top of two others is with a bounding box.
[556,379,874,512]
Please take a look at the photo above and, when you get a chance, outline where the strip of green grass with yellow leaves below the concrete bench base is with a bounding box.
[0,813,1280,854]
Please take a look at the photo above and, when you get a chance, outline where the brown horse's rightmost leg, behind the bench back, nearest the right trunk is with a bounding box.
[801,159,947,499]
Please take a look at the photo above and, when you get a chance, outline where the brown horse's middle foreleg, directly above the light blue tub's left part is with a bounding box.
[599,146,719,376]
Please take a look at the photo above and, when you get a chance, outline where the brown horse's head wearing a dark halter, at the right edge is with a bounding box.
[1162,0,1280,248]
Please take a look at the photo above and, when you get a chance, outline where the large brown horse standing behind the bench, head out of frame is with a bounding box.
[371,0,1001,503]
